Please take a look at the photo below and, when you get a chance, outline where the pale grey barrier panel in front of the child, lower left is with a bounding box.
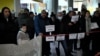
[0,36,42,56]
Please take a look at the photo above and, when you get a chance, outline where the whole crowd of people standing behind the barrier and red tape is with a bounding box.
[0,7,100,56]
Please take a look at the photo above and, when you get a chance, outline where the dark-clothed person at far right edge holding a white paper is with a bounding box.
[91,11,100,55]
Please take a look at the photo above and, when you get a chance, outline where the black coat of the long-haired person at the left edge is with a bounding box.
[0,15,18,44]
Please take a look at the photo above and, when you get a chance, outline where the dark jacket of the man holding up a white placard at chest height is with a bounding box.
[63,15,79,33]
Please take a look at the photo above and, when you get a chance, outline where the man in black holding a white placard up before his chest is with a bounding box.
[63,11,79,56]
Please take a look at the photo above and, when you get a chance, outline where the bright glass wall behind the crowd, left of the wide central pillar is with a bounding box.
[20,0,46,14]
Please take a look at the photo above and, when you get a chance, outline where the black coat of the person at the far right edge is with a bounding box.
[91,16,100,53]
